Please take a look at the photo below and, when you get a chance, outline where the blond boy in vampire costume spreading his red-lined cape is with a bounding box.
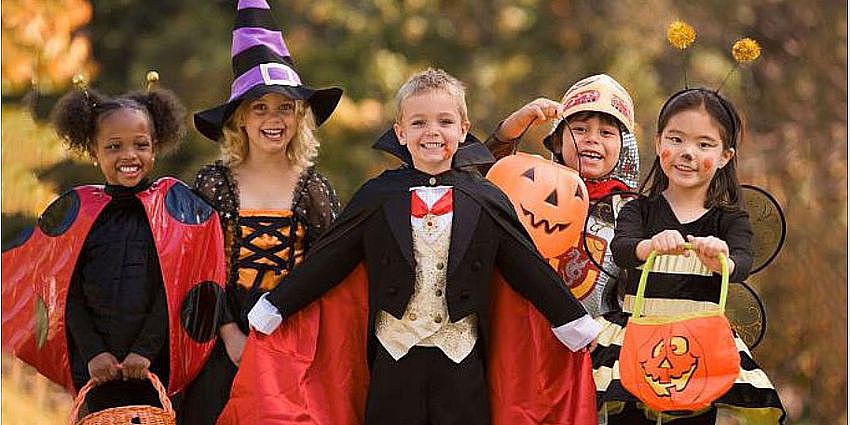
[219,70,599,425]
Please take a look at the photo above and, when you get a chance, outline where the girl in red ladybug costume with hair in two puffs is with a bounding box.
[3,77,224,412]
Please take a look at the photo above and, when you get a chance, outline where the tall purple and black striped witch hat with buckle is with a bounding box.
[195,0,342,141]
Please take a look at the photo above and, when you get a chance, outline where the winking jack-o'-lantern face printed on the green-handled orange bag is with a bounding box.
[640,336,699,397]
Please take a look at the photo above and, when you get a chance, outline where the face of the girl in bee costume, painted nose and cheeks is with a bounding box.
[655,108,735,194]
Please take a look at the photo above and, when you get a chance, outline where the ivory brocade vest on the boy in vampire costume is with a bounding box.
[375,186,478,363]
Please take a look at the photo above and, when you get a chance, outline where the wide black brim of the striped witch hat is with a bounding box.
[194,85,342,141]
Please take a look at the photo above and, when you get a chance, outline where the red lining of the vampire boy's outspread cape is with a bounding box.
[218,167,596,425]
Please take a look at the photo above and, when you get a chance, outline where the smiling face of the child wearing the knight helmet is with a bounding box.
[561,112,622,179]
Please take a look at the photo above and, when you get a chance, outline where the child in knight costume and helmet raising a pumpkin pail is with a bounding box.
[485,74,639,317]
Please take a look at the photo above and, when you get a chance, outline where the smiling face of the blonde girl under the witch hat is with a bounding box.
[241,93,298,156]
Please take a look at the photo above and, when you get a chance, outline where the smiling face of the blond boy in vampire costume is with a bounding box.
[393,89,469,174]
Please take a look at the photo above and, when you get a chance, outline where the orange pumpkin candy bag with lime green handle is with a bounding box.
[620,244,741,416]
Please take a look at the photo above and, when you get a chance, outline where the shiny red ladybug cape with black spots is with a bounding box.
[2,177,225,394]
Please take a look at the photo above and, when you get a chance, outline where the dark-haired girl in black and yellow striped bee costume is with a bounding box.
[593,89,785,424]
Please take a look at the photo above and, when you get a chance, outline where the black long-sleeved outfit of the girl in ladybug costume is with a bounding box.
[66,181,168,384]
